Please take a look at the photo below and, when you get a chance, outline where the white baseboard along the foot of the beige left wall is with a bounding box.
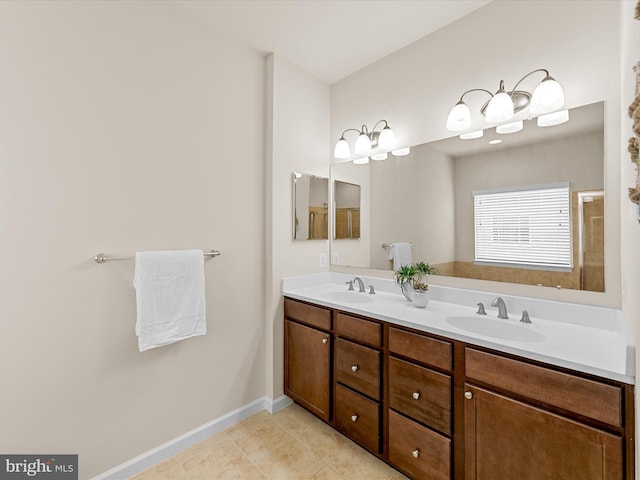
[91,395,291,480]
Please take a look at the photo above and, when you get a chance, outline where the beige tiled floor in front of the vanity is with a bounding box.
[129,404,407,480]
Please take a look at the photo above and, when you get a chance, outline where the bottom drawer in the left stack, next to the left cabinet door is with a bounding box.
[335,385,380,453]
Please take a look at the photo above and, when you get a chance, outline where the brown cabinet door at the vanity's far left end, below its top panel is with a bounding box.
[284,320,331,421]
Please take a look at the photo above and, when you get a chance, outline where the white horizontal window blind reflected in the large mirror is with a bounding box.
[473,183,572,270]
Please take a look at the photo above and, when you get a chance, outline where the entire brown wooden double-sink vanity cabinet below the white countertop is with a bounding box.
[285,299,635,480]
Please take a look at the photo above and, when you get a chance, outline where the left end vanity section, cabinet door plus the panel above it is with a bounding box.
[284,299,331,422]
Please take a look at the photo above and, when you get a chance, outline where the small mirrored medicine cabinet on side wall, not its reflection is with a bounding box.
[293,172,329,240]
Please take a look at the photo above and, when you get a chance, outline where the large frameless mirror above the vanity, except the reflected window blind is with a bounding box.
[331,102,605,292]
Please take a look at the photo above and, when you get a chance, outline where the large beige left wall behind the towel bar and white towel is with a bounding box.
[0,2,268,479]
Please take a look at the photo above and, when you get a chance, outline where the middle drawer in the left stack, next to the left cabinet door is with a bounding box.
[335,338,380,400]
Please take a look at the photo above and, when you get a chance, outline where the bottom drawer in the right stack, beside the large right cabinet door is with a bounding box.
[389,410,451,480]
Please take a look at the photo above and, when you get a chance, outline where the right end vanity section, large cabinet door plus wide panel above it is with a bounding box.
[464,347,633,480]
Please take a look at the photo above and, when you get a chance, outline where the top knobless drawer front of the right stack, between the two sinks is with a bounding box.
[389,327,453,370]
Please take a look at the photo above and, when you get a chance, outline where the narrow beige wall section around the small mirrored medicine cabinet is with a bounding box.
[265,55,329,399]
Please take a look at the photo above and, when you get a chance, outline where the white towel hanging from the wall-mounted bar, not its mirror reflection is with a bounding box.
[133,250,207,352]
